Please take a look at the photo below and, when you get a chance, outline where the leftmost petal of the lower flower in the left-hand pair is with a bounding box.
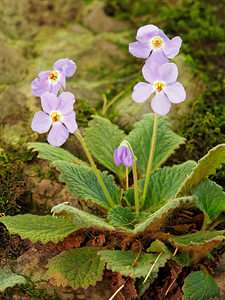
[31,111,52,133]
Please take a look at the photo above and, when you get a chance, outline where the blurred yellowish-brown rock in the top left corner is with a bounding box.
[0,0,83,39]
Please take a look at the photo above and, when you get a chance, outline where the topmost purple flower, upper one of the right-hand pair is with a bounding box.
[129,25,182,64]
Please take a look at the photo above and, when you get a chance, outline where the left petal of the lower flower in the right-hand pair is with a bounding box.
[132,82,154,103]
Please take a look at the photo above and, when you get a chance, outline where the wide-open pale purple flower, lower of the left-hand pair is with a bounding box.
[31,92,77,146]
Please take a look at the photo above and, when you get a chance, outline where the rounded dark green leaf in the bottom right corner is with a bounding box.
[182,271,220,300]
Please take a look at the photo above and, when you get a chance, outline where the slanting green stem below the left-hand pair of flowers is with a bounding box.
[74,129,114,207]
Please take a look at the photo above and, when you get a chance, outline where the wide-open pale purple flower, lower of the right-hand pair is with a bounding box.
[132,62,186,115]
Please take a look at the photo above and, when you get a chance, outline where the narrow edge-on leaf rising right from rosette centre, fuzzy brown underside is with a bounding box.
[133,196,197,233]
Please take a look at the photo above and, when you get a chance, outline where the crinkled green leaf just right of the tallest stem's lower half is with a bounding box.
[140,161,196,209]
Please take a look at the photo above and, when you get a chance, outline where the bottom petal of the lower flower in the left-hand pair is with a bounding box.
[48,122,69,147]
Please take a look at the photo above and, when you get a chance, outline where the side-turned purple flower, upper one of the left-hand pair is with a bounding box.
[31,58,76,97]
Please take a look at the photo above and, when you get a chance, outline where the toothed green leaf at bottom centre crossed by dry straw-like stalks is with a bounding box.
[99,250,170,278]
